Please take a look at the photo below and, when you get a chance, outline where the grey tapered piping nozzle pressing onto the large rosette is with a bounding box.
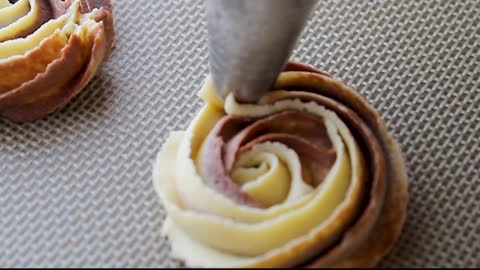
[206,0,317,103]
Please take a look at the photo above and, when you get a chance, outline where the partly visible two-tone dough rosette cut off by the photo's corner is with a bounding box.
[0,0,114,122]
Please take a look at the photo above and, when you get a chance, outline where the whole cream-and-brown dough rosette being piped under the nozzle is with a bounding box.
[154,62,408,267]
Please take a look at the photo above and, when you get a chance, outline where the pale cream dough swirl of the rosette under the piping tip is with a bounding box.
[154,76,364,267]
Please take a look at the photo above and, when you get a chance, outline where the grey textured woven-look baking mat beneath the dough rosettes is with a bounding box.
[0,0,480,267]
